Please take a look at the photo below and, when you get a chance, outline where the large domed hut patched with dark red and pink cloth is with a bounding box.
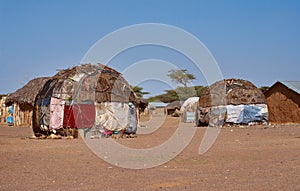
[33,64,140,135]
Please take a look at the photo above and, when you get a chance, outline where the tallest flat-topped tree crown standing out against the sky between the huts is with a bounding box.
[168,69,196,88]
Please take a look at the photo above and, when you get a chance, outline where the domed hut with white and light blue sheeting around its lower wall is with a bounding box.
[196,78,268,126]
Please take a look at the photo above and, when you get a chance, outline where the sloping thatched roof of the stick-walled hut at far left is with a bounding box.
[5,77,49,108]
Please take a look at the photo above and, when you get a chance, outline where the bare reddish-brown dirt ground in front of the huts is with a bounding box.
[0,117,300,191]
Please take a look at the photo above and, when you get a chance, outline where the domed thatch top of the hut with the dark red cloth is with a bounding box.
[40,64,137,103]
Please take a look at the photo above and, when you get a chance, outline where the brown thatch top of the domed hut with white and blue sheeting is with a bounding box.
[199,78,266,107]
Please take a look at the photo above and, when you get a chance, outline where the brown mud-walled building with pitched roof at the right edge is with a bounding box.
[265,81,300,123]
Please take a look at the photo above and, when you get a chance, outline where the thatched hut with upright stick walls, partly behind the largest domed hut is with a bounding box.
[5,77,48,126]
